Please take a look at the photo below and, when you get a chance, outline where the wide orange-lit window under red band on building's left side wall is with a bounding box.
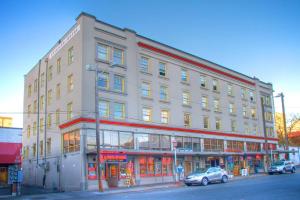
[63,130,80,153]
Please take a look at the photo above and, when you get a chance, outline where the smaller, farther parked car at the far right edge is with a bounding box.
[268,160,296,175]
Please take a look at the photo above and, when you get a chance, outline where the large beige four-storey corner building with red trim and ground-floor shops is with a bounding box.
[23,13,278,190]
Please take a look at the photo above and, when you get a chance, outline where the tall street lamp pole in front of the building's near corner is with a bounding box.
[86,65,104,192]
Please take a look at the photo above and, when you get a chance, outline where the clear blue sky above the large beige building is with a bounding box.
[0,0,300,127]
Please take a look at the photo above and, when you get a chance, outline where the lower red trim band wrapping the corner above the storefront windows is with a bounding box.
[59,118,278,141]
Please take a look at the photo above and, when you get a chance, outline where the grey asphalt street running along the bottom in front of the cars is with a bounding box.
[14,169,300,200]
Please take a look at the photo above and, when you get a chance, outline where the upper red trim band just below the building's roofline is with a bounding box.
[138,42,255,86]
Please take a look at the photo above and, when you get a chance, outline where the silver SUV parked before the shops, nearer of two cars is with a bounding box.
[184,167,228,186]
